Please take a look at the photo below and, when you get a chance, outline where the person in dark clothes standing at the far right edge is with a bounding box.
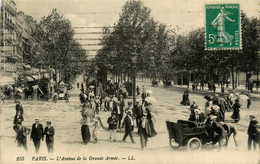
[247,115,260,151]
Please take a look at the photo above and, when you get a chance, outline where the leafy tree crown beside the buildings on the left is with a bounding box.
[31,9,86,81]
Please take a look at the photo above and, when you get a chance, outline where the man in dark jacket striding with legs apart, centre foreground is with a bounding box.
[122,111,135,143]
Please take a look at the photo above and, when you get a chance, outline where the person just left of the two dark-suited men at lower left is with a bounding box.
[16,121,31,151]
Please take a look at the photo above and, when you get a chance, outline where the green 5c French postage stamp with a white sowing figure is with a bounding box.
[205,4,242,50]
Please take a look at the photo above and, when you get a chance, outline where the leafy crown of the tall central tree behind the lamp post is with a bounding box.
[96,0,173,81]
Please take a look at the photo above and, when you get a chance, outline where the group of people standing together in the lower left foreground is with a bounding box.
[13,99,55,153]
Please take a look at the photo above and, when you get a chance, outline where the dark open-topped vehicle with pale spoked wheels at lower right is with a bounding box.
[166,120,228,151]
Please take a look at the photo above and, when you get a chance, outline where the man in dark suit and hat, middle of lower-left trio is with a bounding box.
[31,118,44,153]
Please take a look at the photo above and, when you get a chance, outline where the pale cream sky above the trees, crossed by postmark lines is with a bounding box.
[15,0,260,56]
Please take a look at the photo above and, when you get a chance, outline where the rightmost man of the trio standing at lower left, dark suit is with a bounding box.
[44,121,55,153]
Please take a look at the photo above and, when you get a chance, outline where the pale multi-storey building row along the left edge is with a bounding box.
[0,0,36,83]
